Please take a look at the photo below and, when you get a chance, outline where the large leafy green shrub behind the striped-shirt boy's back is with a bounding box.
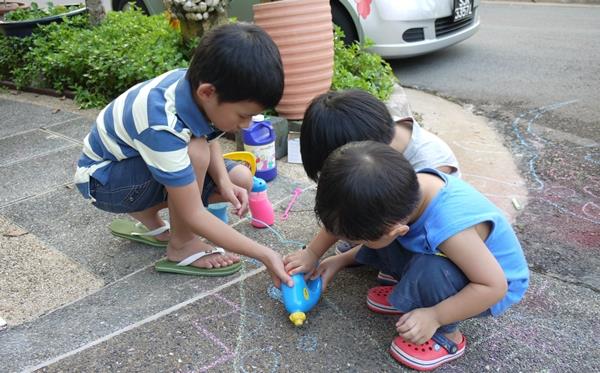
[13,11,189,107]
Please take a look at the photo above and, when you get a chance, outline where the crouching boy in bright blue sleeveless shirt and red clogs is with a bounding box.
[291,141,529,370]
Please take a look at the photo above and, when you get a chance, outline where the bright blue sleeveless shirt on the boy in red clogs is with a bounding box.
[397,168,529,316]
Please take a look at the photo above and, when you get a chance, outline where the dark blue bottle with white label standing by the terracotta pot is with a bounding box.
[242,115,277,181]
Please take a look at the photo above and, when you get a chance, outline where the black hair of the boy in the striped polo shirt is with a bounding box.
[186,22,283,108]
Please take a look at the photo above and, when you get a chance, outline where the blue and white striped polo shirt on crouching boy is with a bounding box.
[75,69,218,186]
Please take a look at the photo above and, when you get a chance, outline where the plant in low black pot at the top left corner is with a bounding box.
[0,2,87,37]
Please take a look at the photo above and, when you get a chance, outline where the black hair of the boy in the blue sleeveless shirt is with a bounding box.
[315,141,421,241]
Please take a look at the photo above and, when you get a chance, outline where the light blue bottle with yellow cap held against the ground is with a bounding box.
[281,273,323,326]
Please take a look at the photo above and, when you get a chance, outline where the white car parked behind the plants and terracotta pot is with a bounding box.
[109,0,480,58]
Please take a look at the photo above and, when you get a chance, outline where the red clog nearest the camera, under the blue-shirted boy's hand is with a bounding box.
[390,333,467,371]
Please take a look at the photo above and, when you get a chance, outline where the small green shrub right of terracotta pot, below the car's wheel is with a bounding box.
[331,26,397,101]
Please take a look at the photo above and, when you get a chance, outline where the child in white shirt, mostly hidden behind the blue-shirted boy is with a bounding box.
[285,89,460,285]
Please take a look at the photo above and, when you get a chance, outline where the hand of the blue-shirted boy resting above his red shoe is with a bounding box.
[396,308,441,345]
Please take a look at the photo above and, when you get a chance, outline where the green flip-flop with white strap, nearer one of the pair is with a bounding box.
[154,247,242,277]
